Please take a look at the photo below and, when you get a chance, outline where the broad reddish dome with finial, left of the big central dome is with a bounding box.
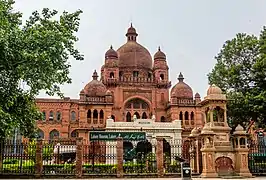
[84,70,107,96]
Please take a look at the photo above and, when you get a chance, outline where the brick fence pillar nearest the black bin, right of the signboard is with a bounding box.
[156,137,164,177]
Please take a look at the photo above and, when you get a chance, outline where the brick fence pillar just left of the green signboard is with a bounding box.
[76,137,83,178]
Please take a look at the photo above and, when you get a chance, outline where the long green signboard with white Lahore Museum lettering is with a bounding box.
[90,131,146,141]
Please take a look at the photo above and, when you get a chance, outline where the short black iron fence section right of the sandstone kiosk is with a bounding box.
[248,142,266,175]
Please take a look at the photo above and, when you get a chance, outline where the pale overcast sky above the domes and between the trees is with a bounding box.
[15,0,266,98]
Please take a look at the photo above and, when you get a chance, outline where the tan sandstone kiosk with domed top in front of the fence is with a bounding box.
[190,85,252,177]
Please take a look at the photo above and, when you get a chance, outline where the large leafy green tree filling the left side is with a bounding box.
[0,0,83,138]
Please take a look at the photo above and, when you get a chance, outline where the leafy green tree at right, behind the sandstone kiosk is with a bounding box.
[208,28,266,127]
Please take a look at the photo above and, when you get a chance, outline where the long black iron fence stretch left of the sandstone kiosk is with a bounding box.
[0,139,200,176]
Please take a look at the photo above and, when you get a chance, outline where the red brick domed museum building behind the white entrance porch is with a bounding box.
[36,25,203,142]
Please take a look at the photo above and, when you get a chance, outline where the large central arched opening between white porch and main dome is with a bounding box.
[124,98,150,121]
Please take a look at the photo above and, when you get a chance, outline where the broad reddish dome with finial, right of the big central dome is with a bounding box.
[171,73,193,99]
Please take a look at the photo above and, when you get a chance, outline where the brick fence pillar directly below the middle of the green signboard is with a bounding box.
[116,138,124,178]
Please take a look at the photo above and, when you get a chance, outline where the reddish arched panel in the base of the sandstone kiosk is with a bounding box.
[215,156,234,175]
